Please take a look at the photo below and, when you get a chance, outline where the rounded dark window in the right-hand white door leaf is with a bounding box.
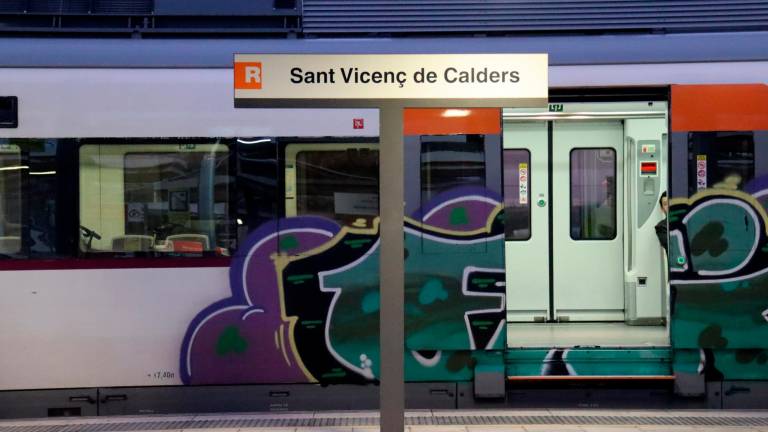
[570,148,616,240]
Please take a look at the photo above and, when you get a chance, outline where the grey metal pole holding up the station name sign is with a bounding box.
[379,103,405,432]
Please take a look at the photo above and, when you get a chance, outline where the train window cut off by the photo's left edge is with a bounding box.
[0,144,22,256]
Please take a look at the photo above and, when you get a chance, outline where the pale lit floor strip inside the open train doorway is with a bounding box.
[507,322,669,348]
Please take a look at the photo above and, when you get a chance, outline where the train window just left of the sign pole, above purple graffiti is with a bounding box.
[285,144,379,226]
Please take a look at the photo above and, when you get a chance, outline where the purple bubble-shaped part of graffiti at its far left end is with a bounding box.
[180,217,339,384]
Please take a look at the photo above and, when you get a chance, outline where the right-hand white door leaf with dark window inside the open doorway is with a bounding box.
[550,120,624,321]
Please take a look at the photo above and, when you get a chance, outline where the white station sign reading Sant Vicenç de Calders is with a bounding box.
[234,54,548,100]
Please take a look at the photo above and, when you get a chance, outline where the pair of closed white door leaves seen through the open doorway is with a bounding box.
[504,121,624,321]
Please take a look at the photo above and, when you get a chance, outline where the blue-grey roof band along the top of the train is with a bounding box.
[0,31,768,68]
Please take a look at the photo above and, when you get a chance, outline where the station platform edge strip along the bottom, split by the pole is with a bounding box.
[0,410,768,432]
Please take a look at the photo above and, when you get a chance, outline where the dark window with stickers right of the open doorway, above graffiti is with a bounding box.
[688,132,755,195]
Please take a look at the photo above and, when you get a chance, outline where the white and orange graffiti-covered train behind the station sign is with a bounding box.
[0,36,768,417]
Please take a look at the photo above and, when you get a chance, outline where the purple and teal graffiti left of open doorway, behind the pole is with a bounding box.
[180,188,506,384]
